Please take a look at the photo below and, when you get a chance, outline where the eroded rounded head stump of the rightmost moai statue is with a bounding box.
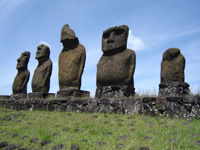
[163,48,180,61]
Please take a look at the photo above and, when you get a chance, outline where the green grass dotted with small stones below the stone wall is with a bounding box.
[0,108,200,150]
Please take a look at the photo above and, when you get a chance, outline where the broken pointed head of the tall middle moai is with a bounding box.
[60,24,77,42]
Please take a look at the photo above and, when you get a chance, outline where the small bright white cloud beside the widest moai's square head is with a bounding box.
[128,30,146,51]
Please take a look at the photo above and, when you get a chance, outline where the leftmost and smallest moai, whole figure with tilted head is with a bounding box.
[12,51,30,94]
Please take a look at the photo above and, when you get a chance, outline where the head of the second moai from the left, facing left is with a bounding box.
[35,44,50,59]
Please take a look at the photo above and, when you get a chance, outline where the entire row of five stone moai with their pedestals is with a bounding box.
[12,24,189,98]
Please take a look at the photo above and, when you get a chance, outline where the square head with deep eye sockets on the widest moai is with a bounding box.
[102,25,129,51]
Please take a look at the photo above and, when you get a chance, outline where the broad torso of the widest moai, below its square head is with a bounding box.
[97,50,135,86]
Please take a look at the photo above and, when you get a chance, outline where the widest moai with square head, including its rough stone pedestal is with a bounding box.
[96,25,136,98]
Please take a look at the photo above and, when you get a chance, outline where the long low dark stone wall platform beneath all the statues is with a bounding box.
[0,95,200,119]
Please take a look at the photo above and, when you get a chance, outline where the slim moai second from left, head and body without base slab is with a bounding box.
[32,44,52,93]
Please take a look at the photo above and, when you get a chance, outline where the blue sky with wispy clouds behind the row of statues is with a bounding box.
[0,0,200,96]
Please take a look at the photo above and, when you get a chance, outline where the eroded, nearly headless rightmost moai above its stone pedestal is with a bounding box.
[161,48,185,83]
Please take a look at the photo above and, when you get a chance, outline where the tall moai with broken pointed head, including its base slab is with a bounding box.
[57,24,89,97]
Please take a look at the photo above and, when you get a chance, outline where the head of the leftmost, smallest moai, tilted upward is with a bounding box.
[16,51,31,69]
